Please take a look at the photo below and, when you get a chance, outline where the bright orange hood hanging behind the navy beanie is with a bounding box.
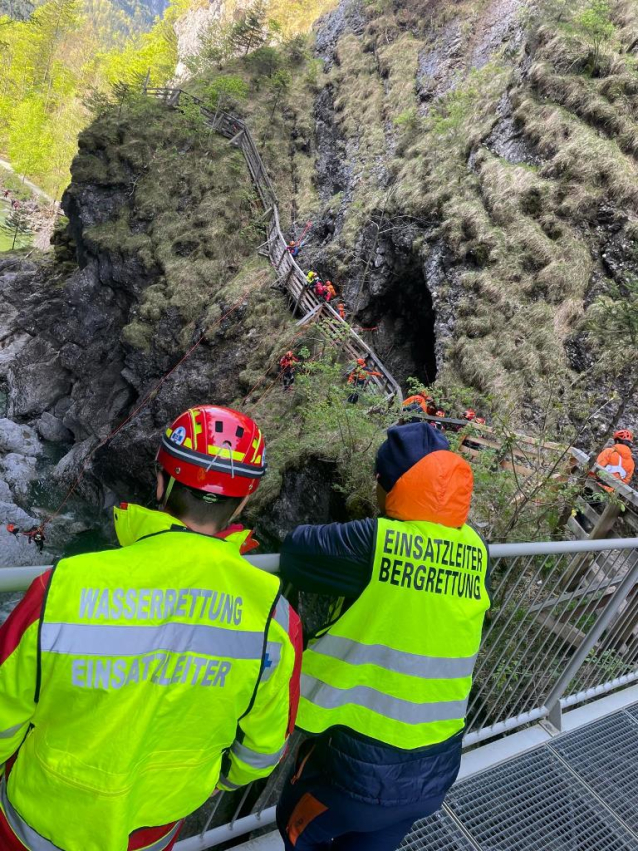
[385,449,474,528]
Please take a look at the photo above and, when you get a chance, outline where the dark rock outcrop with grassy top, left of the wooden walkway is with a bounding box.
[0,98,340,552]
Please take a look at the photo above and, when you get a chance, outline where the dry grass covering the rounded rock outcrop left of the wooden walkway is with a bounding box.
[71,99,276,350]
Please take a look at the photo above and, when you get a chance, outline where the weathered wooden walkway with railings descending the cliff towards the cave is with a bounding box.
[145,88,403,404]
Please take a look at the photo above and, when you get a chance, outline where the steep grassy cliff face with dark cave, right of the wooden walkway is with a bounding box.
[296,0,638,439]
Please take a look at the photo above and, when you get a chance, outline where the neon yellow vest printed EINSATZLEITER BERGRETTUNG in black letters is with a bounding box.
[297,519,490,749]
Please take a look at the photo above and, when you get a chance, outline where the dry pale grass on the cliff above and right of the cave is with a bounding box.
[314,0,638,416]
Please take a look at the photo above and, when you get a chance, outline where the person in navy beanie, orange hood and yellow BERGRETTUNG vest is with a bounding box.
[277,423,490,851]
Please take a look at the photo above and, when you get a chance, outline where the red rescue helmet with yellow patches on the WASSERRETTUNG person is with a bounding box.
[157,405,266,497]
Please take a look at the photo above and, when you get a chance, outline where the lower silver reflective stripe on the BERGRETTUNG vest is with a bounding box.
[301,674,467,724]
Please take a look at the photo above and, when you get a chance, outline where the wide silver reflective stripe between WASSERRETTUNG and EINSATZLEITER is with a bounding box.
[40,622,264,659]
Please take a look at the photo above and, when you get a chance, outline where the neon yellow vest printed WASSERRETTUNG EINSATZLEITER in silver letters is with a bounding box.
[2,506,280,851]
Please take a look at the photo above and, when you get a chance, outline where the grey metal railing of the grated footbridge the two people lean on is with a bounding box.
[0,538,638,851]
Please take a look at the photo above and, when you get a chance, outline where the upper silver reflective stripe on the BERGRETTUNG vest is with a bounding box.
[309,633,477,680]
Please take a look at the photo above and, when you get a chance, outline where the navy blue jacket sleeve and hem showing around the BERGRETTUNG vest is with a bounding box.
[280,519,484,806]
